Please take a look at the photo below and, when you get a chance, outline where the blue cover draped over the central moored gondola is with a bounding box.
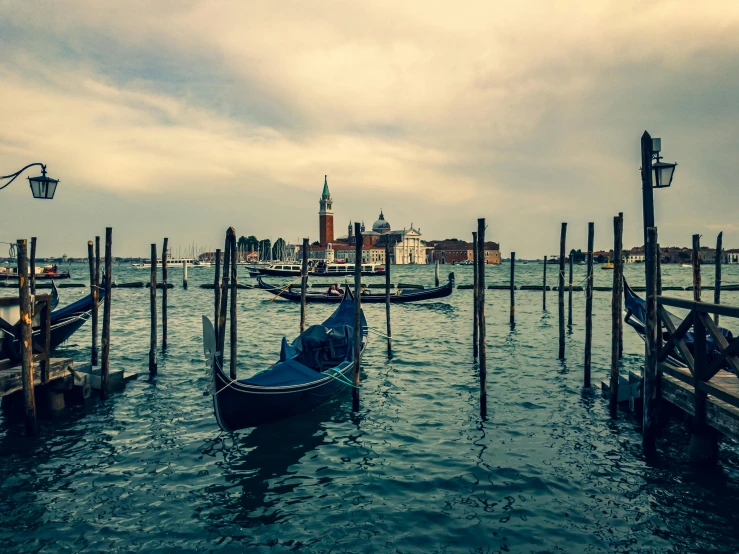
[246,295,367,387]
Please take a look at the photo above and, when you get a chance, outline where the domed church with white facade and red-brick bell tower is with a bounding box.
[310,176,426,265]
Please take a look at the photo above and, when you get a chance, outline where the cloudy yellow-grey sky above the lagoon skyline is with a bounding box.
[0,0,739,258]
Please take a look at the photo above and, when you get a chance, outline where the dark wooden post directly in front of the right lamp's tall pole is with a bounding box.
[642,227,661,454]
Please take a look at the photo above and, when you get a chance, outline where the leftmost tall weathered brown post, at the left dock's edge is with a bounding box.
[17,239,38,435]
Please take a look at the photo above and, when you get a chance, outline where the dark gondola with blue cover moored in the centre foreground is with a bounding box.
[203,282,368,431]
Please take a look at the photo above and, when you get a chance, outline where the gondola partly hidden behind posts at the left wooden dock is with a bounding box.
[0,281,105,360]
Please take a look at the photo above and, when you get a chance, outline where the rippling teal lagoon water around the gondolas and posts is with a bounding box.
[0,263,739,553]
